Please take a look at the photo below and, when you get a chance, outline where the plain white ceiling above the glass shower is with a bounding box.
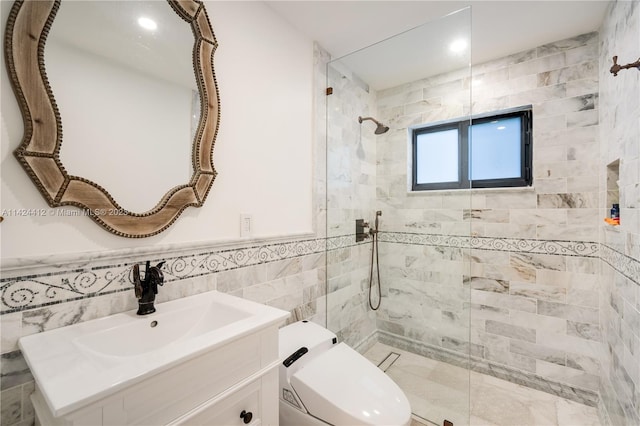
[266,0,610,89]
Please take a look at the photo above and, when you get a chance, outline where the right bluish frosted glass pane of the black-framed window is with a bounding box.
[469,117,522,180]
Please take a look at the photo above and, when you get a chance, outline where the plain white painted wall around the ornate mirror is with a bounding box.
[0,1,313,259]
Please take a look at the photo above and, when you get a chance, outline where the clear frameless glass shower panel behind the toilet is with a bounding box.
[326,8,472,425]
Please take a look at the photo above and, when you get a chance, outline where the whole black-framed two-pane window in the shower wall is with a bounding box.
[411,106,532,191]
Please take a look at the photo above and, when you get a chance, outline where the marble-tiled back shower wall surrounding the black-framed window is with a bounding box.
[370,33,602,405]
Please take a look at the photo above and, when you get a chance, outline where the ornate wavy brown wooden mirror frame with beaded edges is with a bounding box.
[5,0,220,238]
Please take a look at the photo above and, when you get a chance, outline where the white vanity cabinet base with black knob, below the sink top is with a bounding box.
[31,326,279,426]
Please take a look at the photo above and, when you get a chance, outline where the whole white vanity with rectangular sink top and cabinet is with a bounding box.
[19,291,289,426]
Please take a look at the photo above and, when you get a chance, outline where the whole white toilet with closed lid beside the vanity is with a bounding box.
[280,321,411,426]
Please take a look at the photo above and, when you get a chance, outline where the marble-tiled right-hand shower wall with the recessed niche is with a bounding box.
[599,1,640,425]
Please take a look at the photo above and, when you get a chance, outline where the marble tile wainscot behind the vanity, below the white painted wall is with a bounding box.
[0,238,328,426]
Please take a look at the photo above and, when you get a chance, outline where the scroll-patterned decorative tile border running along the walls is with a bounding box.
[0,232,640,314]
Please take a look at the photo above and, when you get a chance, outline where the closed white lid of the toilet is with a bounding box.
[291,343,411,425]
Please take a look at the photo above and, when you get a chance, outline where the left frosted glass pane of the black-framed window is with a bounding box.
[416,129,458,184]
